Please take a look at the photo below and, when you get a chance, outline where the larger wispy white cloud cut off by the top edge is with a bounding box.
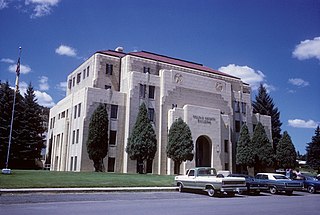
[25,0,60,18]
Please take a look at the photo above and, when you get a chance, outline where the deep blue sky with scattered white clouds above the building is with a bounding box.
[0,0,320,153]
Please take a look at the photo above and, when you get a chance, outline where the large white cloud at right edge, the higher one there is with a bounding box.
[292,37,320,60]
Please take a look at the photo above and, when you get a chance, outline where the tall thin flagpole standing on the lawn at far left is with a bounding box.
[2,47,21,174]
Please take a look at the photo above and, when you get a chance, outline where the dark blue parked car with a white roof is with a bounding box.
[255,173,303,195]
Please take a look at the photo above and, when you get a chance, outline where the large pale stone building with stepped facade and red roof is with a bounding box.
[47,48,271,174]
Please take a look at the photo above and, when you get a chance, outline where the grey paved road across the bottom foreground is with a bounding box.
[0,192,320,215]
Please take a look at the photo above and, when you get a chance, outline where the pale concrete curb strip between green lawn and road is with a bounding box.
[0,187,178,195]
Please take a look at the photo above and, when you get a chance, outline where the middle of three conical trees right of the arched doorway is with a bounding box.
[251,122,275,173]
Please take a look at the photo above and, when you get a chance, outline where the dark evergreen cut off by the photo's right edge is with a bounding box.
[306,126,320,173]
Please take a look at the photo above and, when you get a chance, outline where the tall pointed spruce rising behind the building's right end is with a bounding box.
[252,84,282,148]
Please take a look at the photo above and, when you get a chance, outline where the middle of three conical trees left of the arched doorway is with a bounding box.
[126,103,157,173]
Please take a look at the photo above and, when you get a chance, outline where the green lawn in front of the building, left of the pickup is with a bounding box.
[0,170,174,188]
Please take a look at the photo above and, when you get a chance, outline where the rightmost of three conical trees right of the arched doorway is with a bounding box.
[276,131,297,169]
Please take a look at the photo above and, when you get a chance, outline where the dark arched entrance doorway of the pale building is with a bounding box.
[196,135,212,167]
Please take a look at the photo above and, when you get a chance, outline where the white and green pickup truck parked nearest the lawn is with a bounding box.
[175,167,247,197]
